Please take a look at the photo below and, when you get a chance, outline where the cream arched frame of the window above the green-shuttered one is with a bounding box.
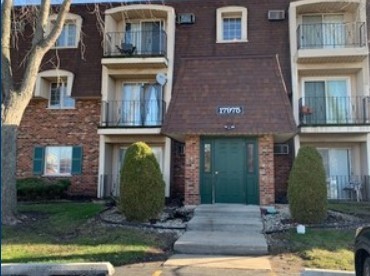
[34,69,75,109]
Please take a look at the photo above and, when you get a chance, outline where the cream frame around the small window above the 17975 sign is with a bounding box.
[216,6,248,43]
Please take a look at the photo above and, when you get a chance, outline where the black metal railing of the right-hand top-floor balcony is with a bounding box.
[297,22,367,49]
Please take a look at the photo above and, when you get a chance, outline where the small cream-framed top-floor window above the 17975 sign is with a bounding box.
[216,6,248,42]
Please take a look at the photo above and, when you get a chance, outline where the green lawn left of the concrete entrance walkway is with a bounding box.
[1,203,172,265]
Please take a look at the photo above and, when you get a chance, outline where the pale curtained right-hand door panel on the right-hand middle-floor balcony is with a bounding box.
[326,80,351,124]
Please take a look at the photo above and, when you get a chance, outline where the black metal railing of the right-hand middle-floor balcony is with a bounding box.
[299,97,370,125]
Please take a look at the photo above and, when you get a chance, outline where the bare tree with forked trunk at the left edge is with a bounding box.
[1,0,71,224]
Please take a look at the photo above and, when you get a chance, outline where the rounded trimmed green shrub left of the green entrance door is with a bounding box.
[118,142,165,221]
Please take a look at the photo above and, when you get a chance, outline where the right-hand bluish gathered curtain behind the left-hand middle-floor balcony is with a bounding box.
[142,84,162,126]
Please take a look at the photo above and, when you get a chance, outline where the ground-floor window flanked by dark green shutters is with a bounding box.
[33,146,82,176]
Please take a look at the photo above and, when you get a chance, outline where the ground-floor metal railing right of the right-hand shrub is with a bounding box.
[326,175,370,201]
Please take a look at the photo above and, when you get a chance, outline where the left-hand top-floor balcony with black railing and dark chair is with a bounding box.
[102,30,167,68]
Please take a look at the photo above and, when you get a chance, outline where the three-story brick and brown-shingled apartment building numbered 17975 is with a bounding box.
[12,0,370,204]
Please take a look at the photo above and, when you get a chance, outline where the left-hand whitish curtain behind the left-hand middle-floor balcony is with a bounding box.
[120,84,141,126]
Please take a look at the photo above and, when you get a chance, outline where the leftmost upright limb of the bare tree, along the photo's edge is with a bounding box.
[1,0,13,103]
